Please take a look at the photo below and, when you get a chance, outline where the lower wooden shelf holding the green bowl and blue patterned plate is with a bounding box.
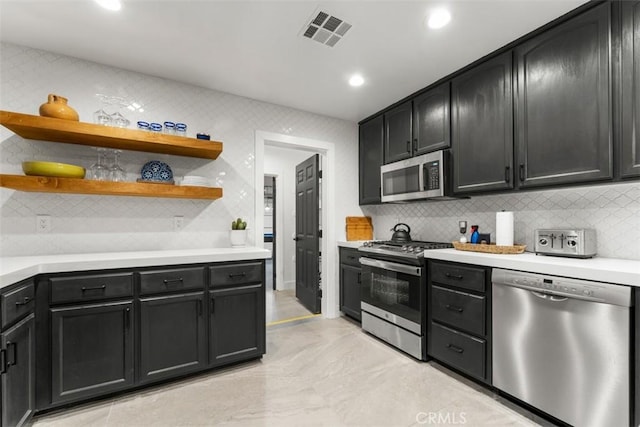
[0,174,222,200]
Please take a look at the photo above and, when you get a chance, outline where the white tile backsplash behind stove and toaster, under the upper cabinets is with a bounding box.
[363,181,640,260]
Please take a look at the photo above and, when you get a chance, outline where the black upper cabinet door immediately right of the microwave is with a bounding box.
[451,52,513,194]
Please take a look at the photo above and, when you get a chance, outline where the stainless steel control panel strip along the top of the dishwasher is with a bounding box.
[491,268,631,305]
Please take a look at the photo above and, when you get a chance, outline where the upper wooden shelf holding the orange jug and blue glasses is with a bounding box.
[0,110,222,160]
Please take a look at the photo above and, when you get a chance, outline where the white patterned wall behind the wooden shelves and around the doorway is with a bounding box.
[0,43,361,256]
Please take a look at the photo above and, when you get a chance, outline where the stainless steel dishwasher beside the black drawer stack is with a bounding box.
[492,269,631,426]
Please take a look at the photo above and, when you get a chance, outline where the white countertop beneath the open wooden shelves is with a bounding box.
[0,247,270,288]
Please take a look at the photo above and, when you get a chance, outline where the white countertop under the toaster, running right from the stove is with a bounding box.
[424,249,640,287]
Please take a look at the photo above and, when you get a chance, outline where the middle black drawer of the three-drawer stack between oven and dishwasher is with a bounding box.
[431,286,486,335]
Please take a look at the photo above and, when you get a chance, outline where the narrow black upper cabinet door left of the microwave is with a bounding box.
[358,115,384,205]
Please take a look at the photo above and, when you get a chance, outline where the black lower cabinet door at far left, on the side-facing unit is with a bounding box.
[0,313,35,426]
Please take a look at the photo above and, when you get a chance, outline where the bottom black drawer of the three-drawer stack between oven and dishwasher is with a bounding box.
[429,322,486,379]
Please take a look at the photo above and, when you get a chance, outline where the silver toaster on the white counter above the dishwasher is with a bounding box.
[534,228,596,258]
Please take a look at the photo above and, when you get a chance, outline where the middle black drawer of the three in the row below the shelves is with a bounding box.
[140,267,204,295]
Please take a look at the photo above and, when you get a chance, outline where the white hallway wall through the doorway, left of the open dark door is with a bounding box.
[264,146,313,290]
